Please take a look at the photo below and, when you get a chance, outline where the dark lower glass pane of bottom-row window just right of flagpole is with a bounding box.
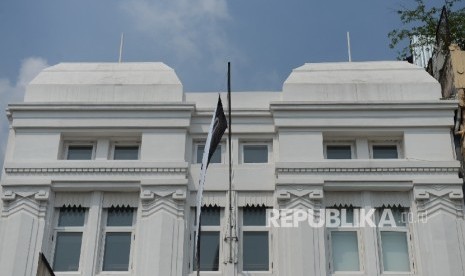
[242,231,269,271]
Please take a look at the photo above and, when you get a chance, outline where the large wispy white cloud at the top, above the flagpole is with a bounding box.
[120,0,238,71]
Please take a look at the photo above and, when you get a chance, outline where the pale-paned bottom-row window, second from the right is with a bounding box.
[329,207,361,272]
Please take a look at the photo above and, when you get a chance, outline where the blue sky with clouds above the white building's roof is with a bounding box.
[0,0,432,164]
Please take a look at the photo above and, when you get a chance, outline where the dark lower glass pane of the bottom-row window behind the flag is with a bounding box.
[194,231,220,271]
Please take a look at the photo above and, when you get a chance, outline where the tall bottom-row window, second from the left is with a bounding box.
[102,207,134,271]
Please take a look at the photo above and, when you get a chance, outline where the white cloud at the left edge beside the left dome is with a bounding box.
[0,57,48,165]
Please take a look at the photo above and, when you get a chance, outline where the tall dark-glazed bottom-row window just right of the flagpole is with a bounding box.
[242,207,270,271]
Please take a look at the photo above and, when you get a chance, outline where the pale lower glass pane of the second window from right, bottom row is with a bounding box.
[331,231,360,271]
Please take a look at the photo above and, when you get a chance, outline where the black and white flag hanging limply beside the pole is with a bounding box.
[194,96,228,270]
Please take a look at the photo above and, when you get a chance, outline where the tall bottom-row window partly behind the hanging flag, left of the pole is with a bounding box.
[192,207,221,271]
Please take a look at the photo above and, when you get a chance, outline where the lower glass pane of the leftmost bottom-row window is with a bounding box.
[53,232,82,271]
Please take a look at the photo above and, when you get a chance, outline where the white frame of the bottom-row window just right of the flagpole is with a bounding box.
[239,206,273,275]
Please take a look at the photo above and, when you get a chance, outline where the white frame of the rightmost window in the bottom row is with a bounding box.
[376,208,415,275]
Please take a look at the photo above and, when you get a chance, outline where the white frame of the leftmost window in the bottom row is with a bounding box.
[50,206,89,273]
